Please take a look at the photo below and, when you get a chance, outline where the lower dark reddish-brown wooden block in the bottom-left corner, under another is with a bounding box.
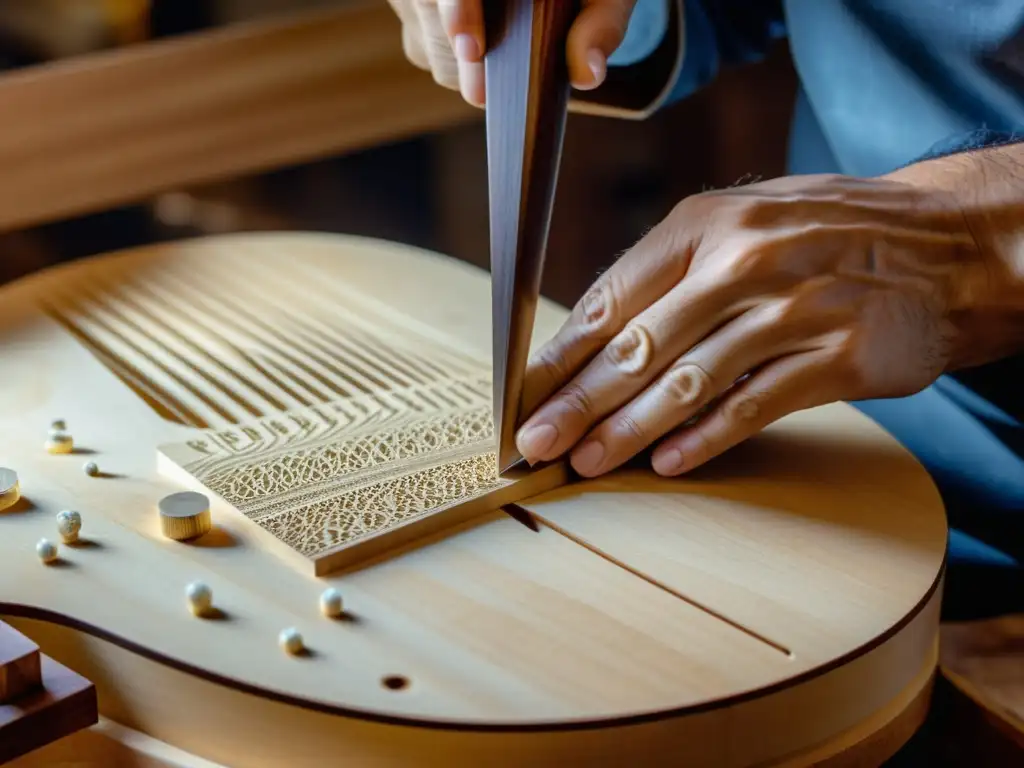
[0,655,99,764]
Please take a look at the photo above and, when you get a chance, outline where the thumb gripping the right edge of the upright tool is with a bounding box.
[565,0,636,90]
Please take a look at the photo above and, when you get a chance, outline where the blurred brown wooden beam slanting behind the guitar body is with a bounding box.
[0,0,482,230]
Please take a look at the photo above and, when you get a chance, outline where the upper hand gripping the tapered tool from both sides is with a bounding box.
[388,0,636,106]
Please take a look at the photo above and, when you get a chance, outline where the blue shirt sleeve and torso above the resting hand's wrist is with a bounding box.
[609,0,1024,176]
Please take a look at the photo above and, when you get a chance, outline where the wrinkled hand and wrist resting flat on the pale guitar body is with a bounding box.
[517,145,1024,476]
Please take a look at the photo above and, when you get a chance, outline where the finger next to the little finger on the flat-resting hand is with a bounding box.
[570,299,831,477]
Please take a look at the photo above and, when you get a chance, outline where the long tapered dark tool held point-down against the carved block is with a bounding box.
[484,0,579,470]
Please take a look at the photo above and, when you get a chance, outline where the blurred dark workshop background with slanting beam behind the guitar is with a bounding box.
[0,0,795,304]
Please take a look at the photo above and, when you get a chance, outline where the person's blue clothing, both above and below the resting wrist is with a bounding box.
[609,0,1024,598]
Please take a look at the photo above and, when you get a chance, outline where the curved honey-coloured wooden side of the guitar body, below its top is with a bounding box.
[6,616,938,768]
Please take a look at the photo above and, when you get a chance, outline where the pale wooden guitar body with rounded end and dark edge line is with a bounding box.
[0,233,947,768]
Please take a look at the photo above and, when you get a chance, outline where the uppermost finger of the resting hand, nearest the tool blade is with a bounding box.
[517,210,700,442]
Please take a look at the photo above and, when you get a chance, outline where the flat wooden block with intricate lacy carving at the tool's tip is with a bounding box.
[160,378,565,574]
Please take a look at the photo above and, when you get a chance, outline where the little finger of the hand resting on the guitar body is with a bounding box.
[651,348,843,476]
